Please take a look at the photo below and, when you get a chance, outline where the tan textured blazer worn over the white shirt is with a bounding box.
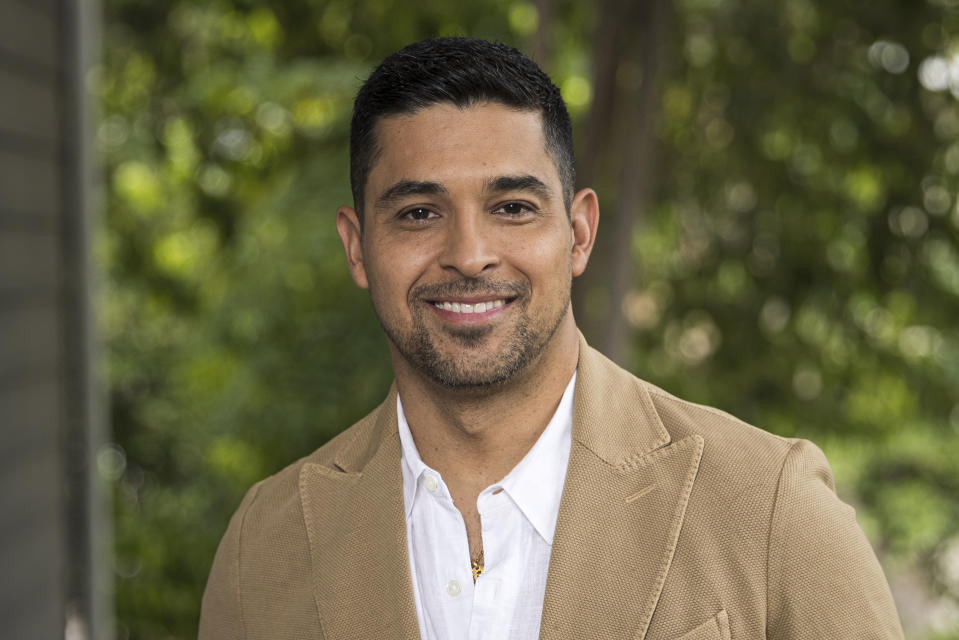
[200,342,902,640]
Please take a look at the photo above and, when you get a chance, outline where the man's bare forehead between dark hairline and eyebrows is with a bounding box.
[367,103,560,198]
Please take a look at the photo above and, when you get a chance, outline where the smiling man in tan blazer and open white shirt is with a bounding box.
[200,38,902,640]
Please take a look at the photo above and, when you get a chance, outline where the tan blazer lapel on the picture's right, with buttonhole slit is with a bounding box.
[540,342,703,640]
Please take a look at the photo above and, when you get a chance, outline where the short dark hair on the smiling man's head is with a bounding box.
[350,37,576,218]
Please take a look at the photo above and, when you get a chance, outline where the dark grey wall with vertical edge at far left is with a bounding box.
[0,0,105,639]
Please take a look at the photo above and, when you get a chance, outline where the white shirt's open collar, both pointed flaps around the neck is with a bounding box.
[396,371,576,545]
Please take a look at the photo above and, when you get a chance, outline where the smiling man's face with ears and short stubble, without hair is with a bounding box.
[337,103,595,387]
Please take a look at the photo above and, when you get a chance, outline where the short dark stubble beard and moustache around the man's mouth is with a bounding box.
[373,278,570,389]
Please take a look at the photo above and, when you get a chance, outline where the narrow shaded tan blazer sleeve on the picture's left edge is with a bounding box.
[198,484,259,640]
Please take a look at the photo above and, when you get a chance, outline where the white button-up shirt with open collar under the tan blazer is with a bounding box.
[396,372,576,640]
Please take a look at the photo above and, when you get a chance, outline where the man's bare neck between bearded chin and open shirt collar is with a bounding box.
[393,314,579,493]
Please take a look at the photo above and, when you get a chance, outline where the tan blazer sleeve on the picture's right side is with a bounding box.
[766,440,903,640]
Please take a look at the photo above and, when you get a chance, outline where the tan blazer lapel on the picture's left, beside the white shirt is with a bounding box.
[300,389,419,640]
